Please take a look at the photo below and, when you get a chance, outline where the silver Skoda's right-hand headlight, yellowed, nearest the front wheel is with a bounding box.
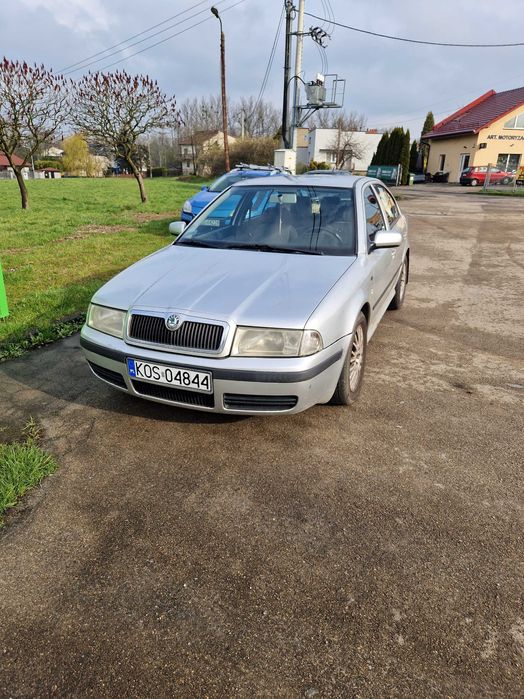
[231,327,322,357]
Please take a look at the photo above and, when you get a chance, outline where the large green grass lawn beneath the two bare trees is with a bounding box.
[0,178,207,359]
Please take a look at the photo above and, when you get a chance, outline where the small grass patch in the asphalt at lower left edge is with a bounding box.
[0,419,58,528]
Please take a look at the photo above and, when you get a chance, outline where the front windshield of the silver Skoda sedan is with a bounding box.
[176,184,356,255]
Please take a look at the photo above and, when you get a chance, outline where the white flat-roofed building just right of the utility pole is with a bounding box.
[308,128,382,174]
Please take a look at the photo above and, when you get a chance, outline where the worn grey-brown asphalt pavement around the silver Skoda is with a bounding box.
[0,185,524,699]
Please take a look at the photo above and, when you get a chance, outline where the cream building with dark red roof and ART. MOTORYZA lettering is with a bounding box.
[423,87,524,182]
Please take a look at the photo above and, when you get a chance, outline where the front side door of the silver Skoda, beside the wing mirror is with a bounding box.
[372,184,406,317]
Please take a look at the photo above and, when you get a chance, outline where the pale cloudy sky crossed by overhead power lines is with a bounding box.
[0,0,524,137]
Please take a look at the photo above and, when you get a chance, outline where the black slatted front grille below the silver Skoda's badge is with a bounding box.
[129,313,224,352]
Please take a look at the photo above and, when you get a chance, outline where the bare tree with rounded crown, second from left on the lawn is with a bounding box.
[73,71,180,203]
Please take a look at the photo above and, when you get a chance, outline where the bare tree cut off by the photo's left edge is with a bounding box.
[0,58,69,209]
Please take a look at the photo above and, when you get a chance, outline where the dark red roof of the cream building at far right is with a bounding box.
[423,87,524,138]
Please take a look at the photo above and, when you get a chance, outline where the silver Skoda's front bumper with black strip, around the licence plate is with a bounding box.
[80,326,349,415]
